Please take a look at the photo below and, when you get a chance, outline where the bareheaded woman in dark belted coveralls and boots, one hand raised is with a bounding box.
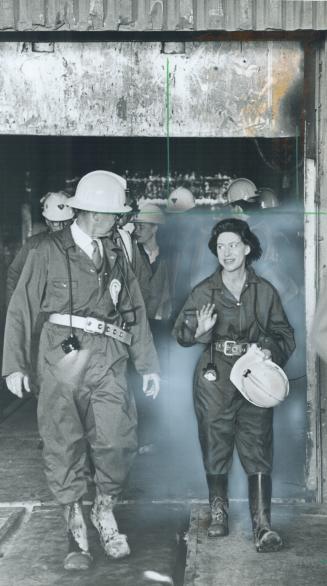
[174,218,295,551]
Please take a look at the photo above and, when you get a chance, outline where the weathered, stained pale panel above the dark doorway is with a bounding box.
[0,42,303,137]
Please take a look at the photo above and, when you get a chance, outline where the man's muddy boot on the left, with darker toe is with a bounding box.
[64,502,92,570]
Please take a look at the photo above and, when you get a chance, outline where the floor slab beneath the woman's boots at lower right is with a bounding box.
[184,503,327,586]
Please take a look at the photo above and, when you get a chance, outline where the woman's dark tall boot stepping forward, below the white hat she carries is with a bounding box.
[248,474,283,552]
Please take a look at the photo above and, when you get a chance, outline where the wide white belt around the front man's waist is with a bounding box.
[49,313,132,346]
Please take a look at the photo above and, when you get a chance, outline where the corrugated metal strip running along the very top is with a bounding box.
[0,0,327,31]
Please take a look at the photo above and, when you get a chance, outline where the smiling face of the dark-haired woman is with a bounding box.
[217,232,251,273]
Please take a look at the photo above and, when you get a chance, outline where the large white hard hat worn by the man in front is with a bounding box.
[69,171,132,214]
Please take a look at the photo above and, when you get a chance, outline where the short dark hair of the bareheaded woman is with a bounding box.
[208,218,262,265]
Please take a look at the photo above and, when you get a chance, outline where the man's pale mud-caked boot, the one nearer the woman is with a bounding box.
[91,491,131,559]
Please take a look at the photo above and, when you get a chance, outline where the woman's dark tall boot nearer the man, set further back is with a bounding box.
[207,474,228,537]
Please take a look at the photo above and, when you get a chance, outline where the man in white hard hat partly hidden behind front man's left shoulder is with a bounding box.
[6,191,74,304]
